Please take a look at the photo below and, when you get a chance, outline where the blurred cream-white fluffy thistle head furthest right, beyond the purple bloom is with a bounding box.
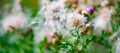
[93,8,113,33]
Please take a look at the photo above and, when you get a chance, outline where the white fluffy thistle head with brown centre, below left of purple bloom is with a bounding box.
[67,13,87,27]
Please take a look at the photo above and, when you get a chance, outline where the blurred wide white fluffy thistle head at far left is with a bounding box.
[1,15,25,31]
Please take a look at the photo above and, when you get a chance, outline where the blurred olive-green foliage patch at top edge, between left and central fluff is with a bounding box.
[21,0,40,17]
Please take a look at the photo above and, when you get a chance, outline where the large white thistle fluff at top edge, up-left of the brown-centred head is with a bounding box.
[40,1,64,24]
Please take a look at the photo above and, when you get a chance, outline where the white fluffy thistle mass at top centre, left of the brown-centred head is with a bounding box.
[38,0,64,28]
